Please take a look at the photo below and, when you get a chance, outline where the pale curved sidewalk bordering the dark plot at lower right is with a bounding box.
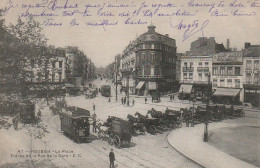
[167,122,255,168]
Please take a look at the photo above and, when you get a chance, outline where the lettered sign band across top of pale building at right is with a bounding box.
[213,51,243,63]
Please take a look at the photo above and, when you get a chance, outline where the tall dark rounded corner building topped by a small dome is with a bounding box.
[135,25,177,95]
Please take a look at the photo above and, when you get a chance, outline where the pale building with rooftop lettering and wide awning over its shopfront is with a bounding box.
[212,51,244,104]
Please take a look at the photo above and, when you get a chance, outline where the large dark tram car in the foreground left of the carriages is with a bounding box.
[60,106,91,143]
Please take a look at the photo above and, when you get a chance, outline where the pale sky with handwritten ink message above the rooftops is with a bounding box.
[0,0,260,67]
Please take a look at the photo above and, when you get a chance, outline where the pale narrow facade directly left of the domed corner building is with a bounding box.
[121,40,137,94]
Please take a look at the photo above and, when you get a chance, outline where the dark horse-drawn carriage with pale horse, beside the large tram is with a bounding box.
[98,117,132,148]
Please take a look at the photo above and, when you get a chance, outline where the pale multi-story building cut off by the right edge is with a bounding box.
[243,43,260,106]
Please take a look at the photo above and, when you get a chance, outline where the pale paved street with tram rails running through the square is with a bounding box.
[0,79,260,168]
